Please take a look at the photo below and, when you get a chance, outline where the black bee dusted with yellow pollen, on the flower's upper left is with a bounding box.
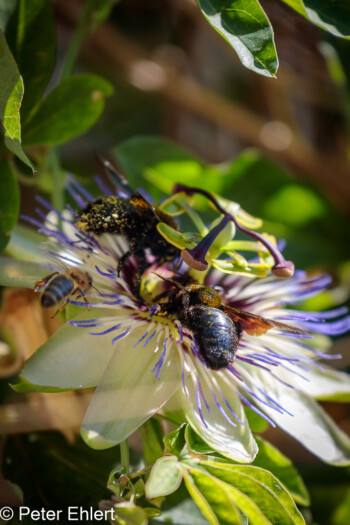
[75,160,180,292]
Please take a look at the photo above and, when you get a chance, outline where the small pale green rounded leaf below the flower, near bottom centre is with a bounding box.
[146,456,182,499]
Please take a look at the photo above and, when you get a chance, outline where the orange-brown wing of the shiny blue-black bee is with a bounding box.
[224,306,309,335]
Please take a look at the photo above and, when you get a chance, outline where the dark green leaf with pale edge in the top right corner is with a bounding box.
[282,0,350,38]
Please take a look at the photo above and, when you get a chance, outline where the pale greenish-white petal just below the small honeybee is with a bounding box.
[21,309,123,389]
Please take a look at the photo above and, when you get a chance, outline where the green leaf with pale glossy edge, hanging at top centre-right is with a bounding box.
[198,0,278,77]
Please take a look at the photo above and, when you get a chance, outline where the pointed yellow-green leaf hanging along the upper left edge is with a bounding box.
[0,30,34,171]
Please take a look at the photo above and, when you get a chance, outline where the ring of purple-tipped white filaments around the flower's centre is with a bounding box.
[25,177,350,438]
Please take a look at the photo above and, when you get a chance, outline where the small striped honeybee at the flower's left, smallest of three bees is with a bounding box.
[34,268,92,317]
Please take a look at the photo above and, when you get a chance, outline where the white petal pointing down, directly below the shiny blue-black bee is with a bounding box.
[167,364,258,463]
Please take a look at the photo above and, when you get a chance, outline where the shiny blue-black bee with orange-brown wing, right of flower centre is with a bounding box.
[159,276,308,370]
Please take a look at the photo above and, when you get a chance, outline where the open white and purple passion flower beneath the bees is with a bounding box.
[9,182,350,465]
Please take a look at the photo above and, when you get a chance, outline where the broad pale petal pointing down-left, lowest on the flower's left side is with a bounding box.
[82,327,181,449]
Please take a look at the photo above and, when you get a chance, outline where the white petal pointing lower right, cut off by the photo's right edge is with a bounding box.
[249,370,350,465]
